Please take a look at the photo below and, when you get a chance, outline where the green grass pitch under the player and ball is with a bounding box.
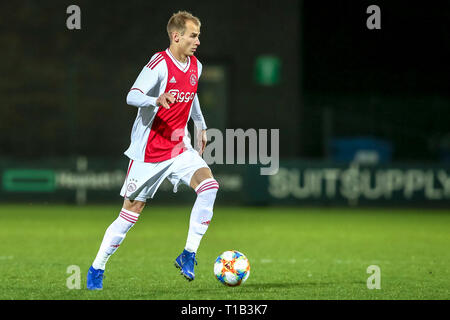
[0,204,450,300]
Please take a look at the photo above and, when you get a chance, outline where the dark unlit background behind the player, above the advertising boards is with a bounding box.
[0,0,450,162]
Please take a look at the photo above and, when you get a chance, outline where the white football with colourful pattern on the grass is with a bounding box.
[214,250,250,287]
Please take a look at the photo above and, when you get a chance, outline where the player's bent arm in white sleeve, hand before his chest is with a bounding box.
[127,53,175,109]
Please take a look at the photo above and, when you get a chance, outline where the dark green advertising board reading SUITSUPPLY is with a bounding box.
[245,160,450,206]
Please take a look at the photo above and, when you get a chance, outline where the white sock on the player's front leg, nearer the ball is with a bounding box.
[185,178,219,252]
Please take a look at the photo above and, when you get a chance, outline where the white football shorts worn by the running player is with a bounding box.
[120,149,209,202]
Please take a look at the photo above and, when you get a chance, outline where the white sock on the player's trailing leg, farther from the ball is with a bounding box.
[92,208,139,270]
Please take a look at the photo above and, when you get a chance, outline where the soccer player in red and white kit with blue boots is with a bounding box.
[87,11,219,290]
